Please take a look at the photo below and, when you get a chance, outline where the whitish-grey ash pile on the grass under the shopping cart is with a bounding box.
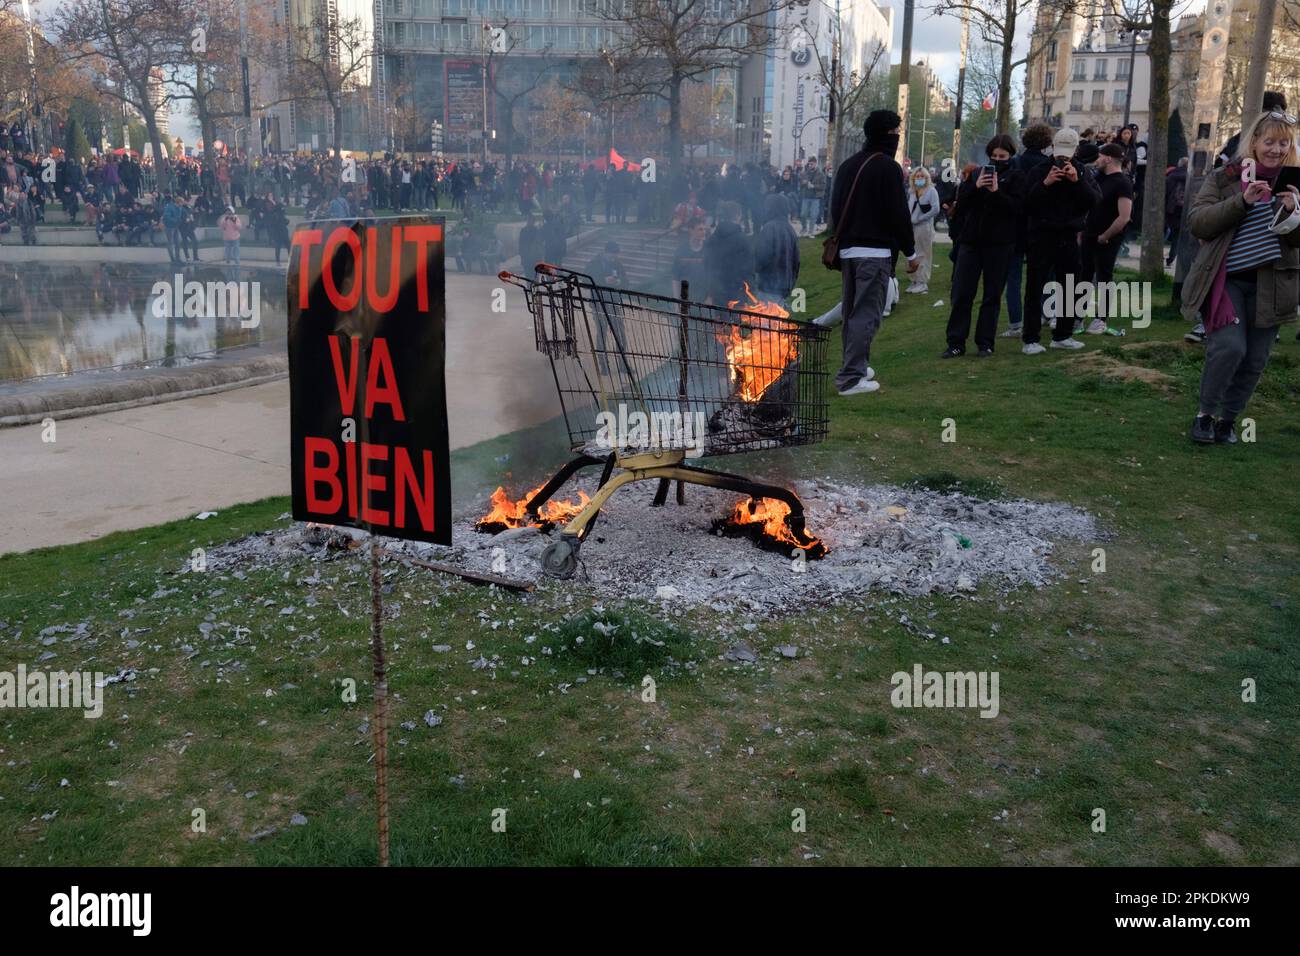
[408,481,1099,613]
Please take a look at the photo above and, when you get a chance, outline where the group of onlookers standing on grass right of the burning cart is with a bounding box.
[814,102,1300,444]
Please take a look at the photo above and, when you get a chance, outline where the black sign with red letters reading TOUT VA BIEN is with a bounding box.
[289,216,451,545]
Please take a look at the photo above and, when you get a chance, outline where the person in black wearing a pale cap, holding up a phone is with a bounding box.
[1021,129,1101,355]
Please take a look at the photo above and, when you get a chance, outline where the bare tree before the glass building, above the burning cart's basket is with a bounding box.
[595,0,798,168]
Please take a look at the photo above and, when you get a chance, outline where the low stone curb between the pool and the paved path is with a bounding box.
[0,352,289,428]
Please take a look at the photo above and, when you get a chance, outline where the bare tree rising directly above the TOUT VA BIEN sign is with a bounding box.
[279,4,374,181]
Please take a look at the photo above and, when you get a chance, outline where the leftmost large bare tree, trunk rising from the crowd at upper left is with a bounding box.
[55,0,187,190]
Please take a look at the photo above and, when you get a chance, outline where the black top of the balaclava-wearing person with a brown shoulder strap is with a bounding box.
[831,150,917,259]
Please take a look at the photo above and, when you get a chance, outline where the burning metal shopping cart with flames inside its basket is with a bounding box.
[491,264,829,578]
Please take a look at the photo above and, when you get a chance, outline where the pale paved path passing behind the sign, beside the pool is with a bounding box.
[0,270,559,553]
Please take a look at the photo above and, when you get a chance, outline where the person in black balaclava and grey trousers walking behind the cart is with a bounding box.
[829,109,920,395]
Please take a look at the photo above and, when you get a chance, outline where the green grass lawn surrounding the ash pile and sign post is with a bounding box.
[0,243,1300,865]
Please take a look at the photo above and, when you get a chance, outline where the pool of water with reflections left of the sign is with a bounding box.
[0,260,286,382]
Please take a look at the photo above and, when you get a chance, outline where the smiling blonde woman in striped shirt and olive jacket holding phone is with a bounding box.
[1183,111,1300,445]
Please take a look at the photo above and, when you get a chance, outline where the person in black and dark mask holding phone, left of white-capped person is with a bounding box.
[940,133,1022,359]
